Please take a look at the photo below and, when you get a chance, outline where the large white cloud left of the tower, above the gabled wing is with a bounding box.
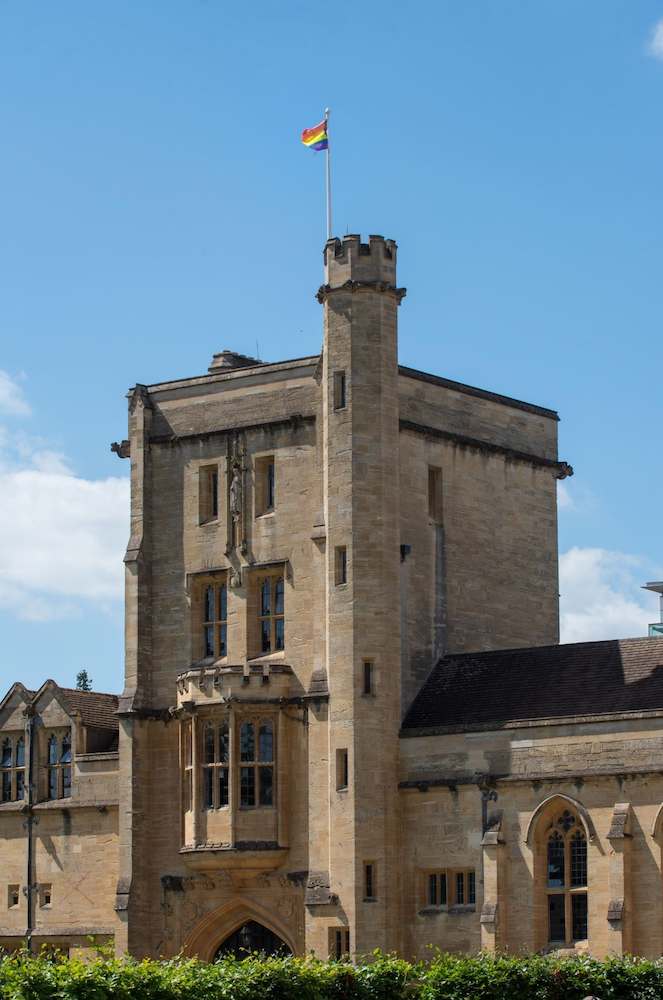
[0,422,129,621]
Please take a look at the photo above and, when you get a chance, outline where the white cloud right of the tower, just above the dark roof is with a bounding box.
[559,547,663,642]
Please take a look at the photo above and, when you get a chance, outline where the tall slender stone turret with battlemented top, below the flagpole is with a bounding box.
[318,235,405,951]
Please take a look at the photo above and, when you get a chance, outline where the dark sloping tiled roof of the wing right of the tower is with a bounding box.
[402,638,663,735]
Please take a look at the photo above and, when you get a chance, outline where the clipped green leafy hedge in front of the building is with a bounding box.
[0,953,663,1000]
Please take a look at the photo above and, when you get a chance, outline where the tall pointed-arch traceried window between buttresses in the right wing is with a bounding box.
[544,809,587,944]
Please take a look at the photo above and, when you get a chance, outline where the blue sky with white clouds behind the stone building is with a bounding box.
[0,0,663,690]
